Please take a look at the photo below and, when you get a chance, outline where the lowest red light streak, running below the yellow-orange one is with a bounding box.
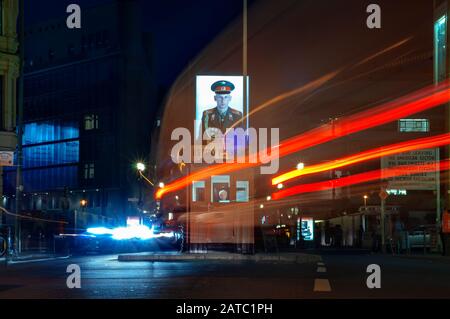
[272,159,450,200]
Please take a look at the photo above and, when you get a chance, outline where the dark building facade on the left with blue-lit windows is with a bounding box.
[4,1,154,240]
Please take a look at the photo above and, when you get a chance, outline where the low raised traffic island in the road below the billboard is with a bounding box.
[117,252,321,264]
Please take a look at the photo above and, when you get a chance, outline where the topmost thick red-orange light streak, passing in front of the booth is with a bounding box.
[155,81,450,199]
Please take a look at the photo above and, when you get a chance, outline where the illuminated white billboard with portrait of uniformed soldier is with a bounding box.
[195,75,247,140]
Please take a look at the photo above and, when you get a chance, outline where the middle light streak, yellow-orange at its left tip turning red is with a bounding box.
[272,133,450,185]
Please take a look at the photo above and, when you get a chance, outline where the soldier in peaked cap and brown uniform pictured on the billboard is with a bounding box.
[201,80,243,138]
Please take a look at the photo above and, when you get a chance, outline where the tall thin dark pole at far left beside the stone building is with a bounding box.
[14,0,25,253]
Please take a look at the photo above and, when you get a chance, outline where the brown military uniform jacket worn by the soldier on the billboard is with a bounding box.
[202,107,244,138]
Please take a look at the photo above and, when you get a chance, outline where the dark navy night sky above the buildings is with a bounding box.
[25,0,251,90]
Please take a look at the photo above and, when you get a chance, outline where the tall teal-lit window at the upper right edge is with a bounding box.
[434,15,447,83]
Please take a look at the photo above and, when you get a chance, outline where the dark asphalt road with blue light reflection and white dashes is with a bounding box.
[0,254,450,299]
